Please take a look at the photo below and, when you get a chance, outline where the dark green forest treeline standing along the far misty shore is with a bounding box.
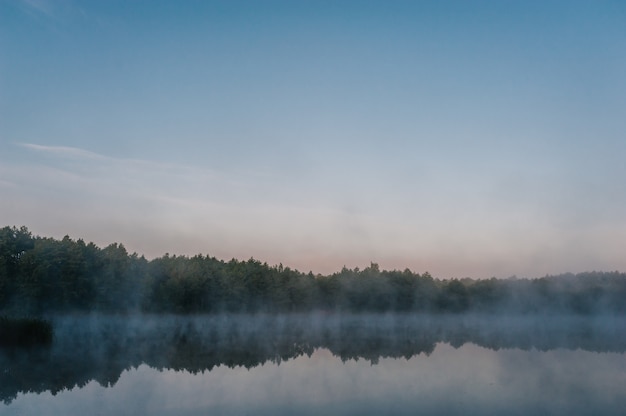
[0,227,626,315]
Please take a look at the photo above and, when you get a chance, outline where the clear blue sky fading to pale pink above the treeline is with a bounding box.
[0,0,626,278]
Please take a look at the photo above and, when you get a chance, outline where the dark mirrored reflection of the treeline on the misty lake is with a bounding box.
[0,314,626,402]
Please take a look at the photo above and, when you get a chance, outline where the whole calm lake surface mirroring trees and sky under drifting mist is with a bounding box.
[0,315,626,415]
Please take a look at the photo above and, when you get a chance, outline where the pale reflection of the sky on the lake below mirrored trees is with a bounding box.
[0,344,626,415]
